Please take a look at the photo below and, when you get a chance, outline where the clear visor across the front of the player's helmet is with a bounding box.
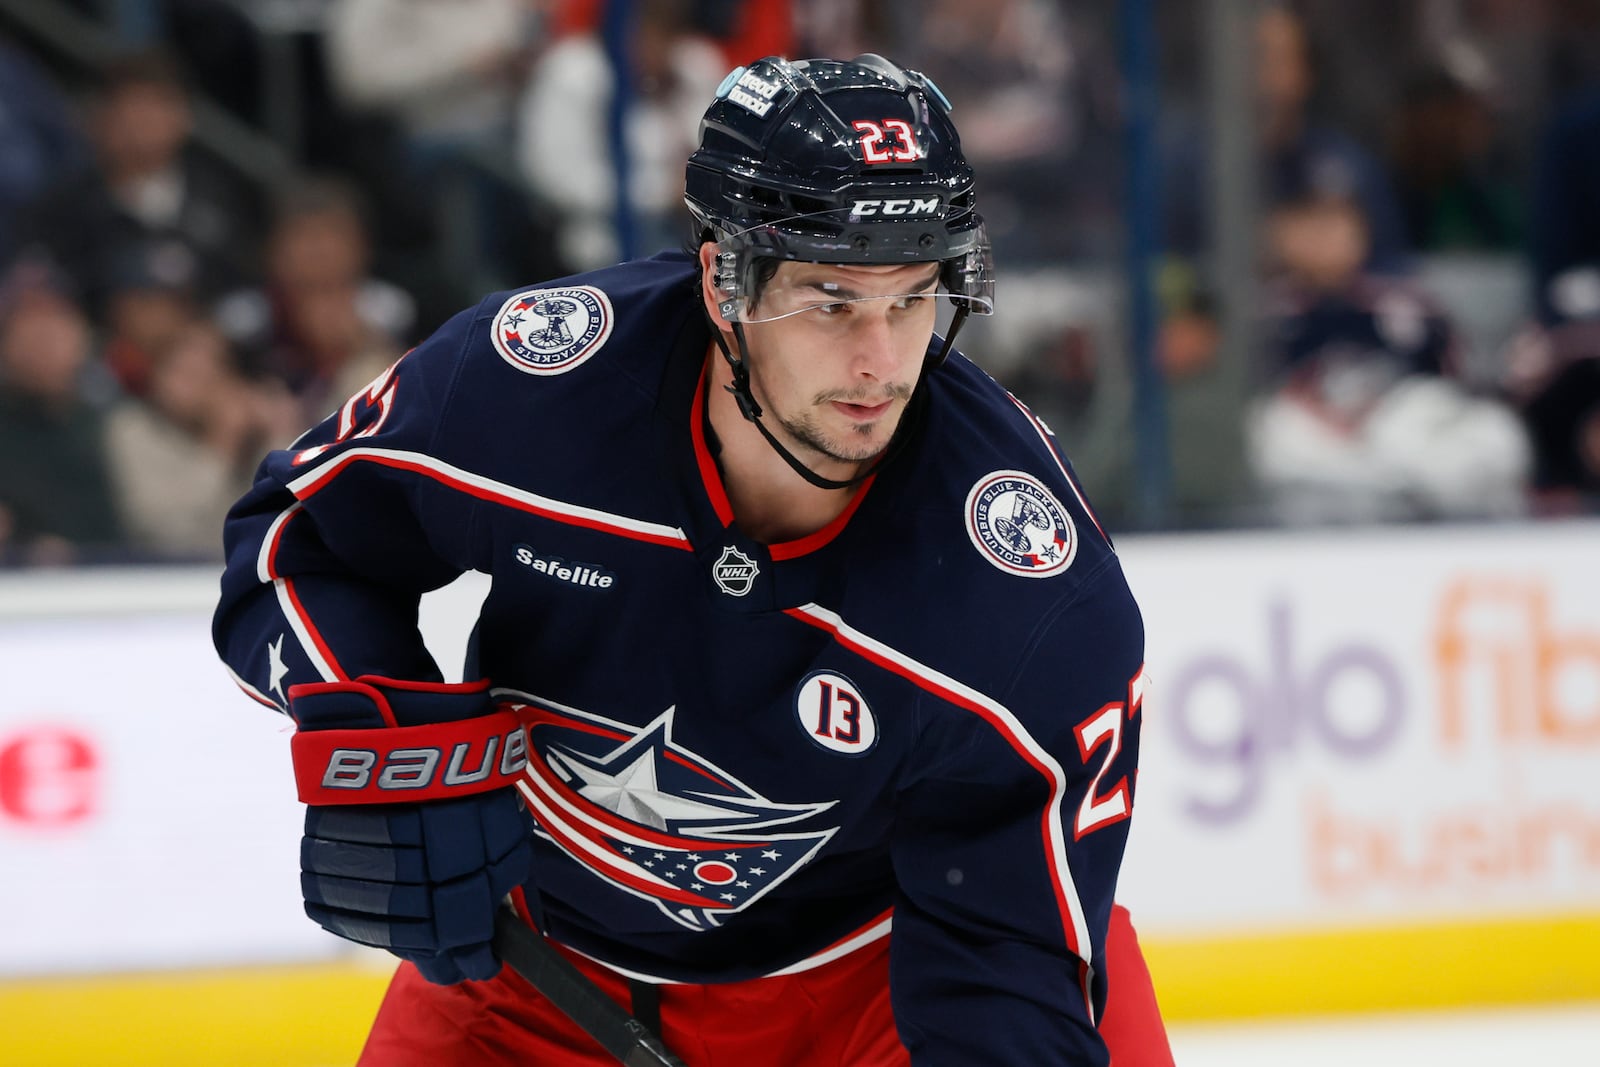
[717,207,994,323]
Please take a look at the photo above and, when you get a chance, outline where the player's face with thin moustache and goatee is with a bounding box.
[744,262,939,464]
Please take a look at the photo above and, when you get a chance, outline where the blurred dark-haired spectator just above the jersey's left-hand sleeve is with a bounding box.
[216,178,416,424]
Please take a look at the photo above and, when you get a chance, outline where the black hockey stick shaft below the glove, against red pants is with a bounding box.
[494,907,688,1067]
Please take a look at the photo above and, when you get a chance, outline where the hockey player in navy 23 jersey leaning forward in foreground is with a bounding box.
[214,56,1171,1067]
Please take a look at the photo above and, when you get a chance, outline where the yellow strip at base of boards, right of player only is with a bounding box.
[1134,913,1600,1022]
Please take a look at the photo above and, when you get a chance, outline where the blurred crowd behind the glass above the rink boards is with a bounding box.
[0,0,1600,565]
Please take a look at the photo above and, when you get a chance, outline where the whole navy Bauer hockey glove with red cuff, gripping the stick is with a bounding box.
[290,675,533,984]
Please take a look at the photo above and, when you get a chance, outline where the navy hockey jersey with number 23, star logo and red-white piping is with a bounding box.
[214,254,1144,1067]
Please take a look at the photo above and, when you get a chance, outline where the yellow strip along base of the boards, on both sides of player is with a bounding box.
[9,913,1600,1067]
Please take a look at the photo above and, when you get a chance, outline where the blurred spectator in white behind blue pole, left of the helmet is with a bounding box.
[517,0,728,269]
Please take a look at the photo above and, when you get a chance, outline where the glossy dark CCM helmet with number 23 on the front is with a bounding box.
[685,54,994,322]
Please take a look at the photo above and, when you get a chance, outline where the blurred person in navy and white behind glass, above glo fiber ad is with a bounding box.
[1246,197,1530,523]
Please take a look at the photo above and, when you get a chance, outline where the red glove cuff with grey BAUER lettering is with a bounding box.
[290,709,528,805]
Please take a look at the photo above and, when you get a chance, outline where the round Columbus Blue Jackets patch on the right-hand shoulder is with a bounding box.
[966,470,1078,577]
